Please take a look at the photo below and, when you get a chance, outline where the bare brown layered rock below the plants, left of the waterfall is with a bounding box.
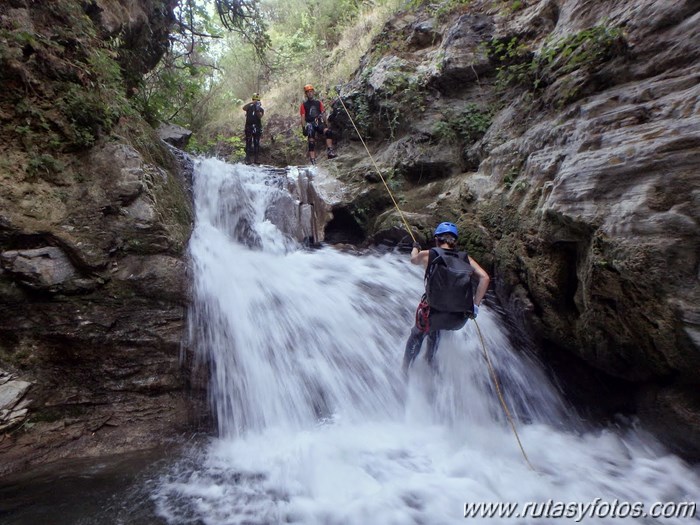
[0,126,194,474]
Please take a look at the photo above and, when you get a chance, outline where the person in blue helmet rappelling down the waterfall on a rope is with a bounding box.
[403,222,490,373]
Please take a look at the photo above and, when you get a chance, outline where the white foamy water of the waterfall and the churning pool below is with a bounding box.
[153,160,700,525]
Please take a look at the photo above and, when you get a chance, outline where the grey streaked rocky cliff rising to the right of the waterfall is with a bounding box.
[334,0,700,455]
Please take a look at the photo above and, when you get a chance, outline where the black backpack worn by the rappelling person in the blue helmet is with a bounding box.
[425,248,474,314]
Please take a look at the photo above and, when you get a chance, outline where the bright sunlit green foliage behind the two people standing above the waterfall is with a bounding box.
[135,0,400,151]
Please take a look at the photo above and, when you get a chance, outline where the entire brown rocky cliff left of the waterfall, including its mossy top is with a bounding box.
[0,0,197,474]
